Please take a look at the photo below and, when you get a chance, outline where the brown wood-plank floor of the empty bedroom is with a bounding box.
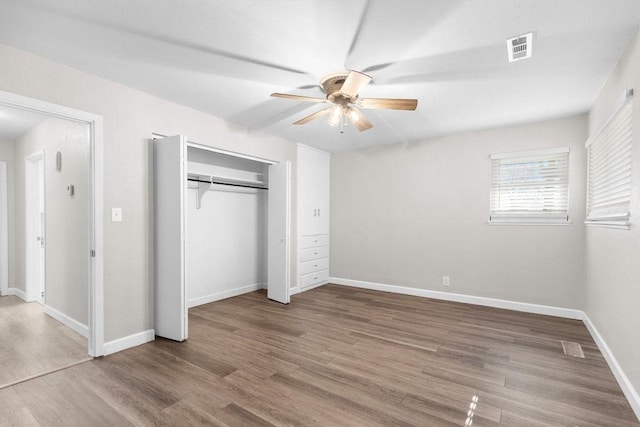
[0,285,639,427]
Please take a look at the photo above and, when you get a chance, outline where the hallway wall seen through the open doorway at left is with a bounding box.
[15,118,89,325]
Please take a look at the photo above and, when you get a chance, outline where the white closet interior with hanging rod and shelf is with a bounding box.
[186,146,268,307]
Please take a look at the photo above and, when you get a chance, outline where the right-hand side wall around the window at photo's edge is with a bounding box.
[585,35,640,402]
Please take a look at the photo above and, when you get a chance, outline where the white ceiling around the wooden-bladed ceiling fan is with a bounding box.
[0,0,640,151]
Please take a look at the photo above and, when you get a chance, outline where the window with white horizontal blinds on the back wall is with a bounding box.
[489,147,569,224]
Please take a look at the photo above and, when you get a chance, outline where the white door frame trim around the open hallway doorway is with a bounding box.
[0,91,104,357]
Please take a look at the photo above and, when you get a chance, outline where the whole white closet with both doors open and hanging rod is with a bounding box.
[154,135,290,341]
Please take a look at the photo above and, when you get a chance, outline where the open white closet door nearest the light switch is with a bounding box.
[154,136,187,341]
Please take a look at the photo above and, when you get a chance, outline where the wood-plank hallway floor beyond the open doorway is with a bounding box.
[0,296,88,390]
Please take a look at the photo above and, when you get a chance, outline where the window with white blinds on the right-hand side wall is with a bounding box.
[586,91,633,229]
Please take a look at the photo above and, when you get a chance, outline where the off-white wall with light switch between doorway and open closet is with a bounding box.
[0,45,296,341]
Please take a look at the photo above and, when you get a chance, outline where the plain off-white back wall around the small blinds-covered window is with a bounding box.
[331,115,587,308]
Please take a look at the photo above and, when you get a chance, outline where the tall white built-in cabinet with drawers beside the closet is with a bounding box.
[296,144,330,291]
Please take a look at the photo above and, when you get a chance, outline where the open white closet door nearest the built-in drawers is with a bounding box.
[267,162,291,304]
